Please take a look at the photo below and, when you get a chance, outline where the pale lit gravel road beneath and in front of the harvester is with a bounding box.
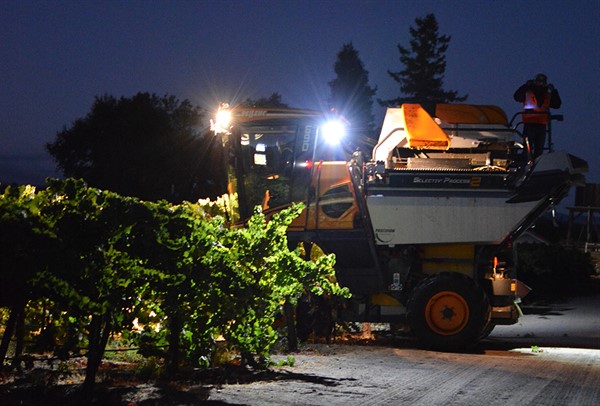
[208,295,600,406]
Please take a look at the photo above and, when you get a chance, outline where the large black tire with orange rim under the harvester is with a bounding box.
[407,273,490,351]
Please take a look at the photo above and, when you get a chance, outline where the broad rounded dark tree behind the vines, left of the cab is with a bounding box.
[46,93,224,202]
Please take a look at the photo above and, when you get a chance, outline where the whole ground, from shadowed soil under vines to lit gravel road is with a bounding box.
[0,294,600,406]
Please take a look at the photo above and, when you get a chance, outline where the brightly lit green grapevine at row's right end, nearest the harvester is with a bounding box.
[203,205,348,361]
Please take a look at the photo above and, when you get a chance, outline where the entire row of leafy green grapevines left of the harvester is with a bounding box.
[0,179,349,382]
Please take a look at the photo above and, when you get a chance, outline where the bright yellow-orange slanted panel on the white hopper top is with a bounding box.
[402,104,450,150]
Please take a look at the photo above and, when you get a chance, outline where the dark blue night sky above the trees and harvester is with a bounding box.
[0,0,600,187]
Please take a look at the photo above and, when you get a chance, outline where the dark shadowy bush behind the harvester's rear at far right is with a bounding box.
[516,244,595,298]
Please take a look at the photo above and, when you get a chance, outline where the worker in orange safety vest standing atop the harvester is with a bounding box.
[513,73,562,159]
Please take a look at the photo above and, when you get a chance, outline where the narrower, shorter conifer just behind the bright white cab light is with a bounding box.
[329,42,377,144]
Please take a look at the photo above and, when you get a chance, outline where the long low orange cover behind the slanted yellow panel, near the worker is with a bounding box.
[435,104,508,125]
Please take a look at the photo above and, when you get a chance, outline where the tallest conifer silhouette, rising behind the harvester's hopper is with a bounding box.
[380,14,468,106]
